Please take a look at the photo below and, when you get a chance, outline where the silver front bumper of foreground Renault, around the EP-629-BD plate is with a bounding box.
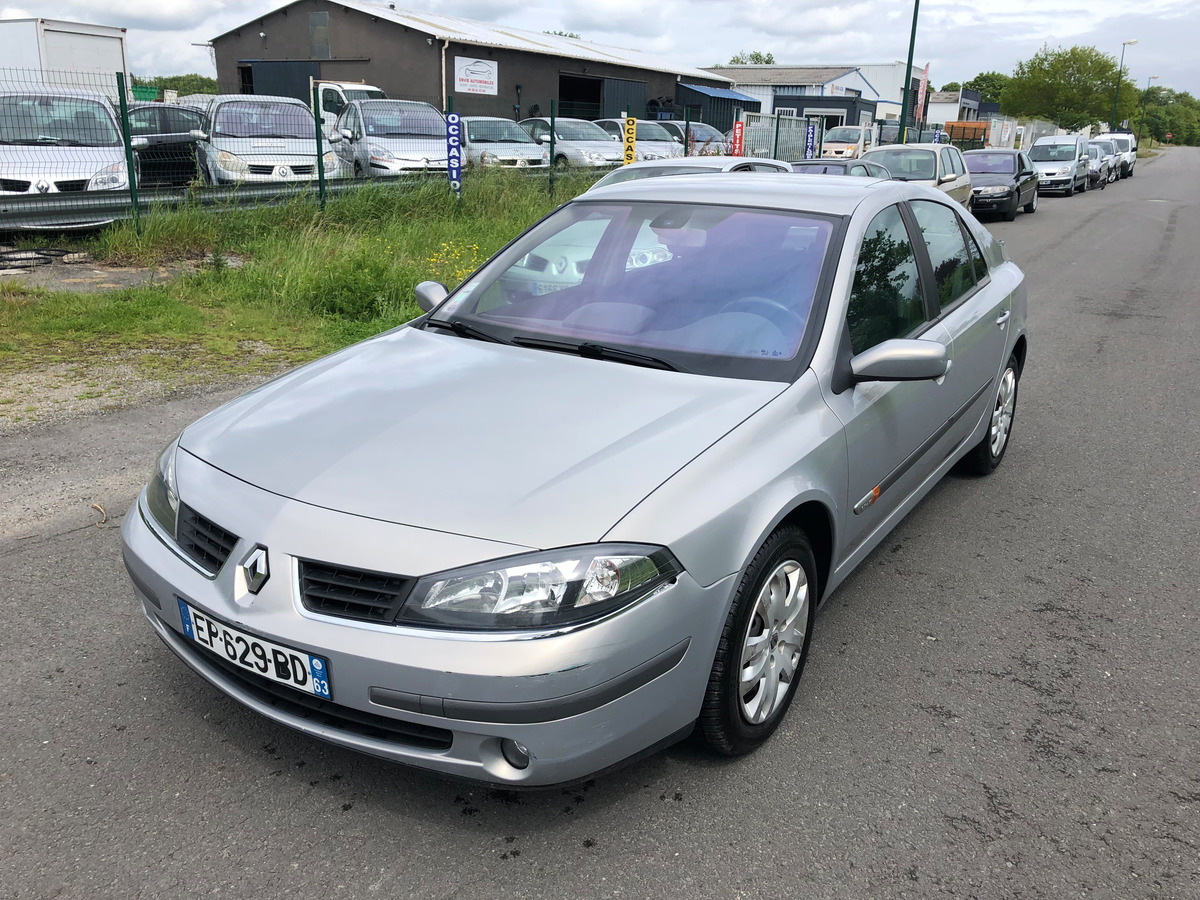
[121,452,736,786]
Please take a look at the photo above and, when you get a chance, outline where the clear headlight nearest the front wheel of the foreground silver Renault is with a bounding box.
[396,544,683,630]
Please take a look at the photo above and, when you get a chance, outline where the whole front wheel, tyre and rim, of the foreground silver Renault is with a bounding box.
[697,526,817,756]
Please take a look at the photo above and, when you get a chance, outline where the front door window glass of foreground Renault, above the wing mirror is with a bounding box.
[846,206,925,353]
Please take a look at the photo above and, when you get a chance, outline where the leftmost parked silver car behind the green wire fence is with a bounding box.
[0,88,145,228]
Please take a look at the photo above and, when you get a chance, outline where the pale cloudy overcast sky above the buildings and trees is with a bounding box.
[0,0,1200,95]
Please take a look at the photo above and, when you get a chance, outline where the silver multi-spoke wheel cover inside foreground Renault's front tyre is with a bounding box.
[738,559,809,725]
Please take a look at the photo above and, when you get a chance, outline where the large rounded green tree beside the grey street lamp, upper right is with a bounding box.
[1000,46,1140,131]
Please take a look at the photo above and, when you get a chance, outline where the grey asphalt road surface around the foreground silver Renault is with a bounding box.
[0,149,1200,900]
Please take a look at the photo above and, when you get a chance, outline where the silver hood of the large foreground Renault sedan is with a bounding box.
[180,328,786,548]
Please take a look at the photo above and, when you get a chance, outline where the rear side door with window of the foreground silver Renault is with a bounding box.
[910,200,1012,446]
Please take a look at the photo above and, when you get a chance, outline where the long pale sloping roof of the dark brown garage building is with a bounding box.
[212,0,733,82]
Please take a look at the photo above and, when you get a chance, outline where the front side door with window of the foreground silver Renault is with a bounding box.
[827,204,953,556]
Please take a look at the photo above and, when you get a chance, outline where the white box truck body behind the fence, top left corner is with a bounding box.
[0,18,130,102]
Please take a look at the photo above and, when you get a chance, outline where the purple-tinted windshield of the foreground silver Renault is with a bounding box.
[437,202,834,373]
